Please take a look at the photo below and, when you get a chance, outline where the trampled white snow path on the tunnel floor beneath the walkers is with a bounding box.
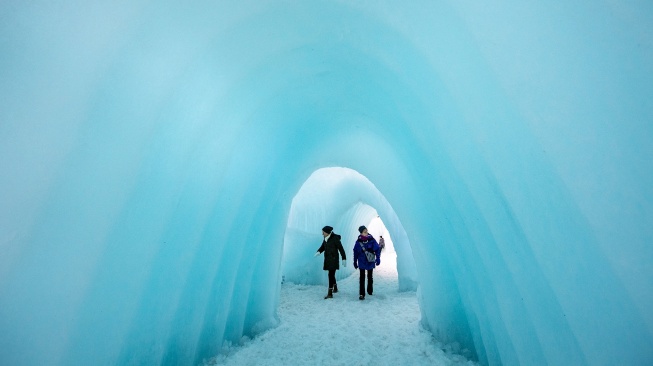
[206,252,475,366]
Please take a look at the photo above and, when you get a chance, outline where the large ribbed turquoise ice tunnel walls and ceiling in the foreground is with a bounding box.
[0,0,653,365]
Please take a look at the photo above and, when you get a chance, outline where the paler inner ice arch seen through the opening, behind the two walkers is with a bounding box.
[281,167,418,291]
